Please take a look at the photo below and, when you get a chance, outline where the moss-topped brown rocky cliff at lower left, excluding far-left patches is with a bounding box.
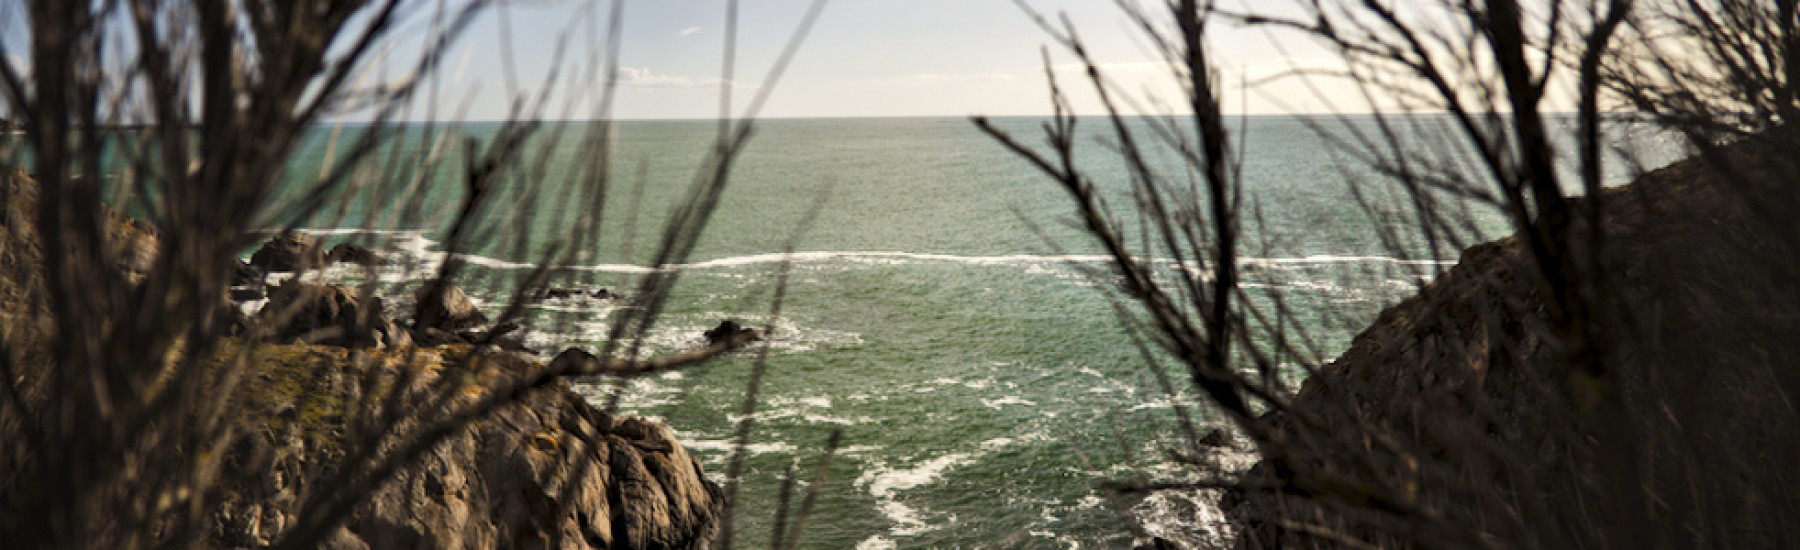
[212,345,720,548]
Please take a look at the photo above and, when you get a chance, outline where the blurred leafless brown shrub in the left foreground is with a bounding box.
[0,0,830,548]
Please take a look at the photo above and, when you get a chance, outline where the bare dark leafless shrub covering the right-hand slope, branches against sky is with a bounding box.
[976,0,1800,548]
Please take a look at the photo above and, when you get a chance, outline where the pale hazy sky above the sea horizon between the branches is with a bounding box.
[421,0,1353,120]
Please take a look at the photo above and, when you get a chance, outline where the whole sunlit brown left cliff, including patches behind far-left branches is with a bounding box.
[0,169,722,548]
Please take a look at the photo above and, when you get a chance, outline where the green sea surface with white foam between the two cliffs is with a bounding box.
[7,117,1679,548]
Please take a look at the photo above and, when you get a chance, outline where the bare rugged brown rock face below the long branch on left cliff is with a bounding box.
[212,347,722,548]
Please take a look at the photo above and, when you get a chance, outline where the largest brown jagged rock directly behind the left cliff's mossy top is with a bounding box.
[259,279,392,347]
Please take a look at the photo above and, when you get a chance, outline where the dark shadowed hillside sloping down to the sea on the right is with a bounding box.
[1226,131,1800,548]
